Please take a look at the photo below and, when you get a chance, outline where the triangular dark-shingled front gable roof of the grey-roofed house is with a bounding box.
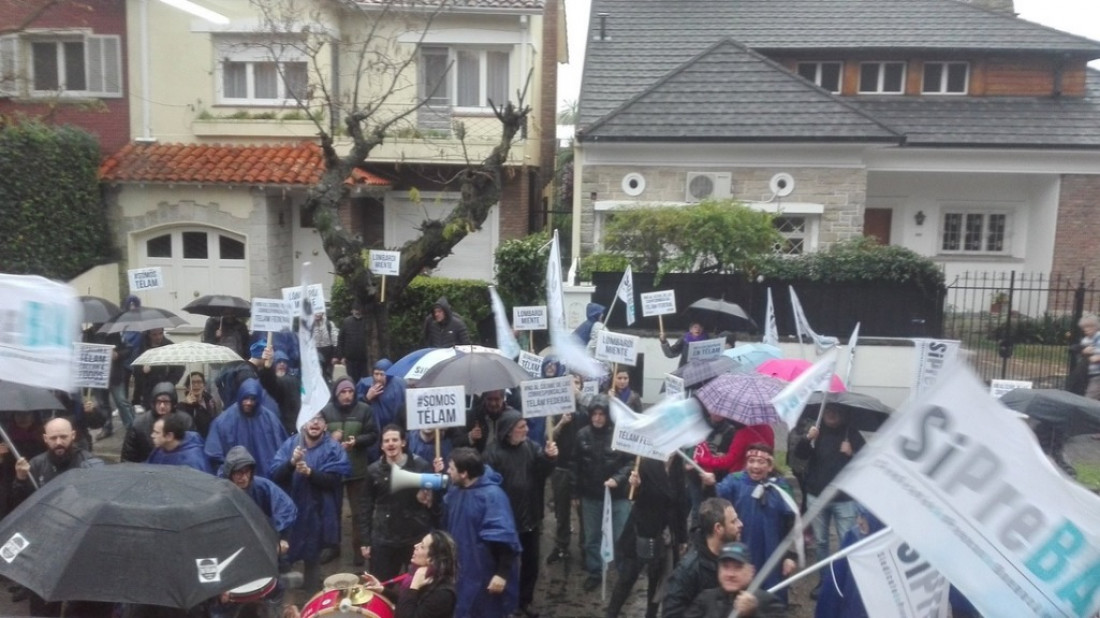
[585,40,901,142]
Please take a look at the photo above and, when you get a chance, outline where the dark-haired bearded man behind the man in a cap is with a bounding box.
[661,498,751,618]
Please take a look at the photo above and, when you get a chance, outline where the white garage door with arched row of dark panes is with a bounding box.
[131,225,252,327]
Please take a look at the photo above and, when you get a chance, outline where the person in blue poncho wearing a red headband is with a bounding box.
[715,442,798,605]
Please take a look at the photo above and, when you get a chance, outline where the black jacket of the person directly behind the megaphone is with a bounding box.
[355,454,433,547]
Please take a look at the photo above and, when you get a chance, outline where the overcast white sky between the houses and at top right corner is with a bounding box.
[558,0,1100,109]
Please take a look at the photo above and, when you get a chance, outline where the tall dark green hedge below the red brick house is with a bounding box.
[0,121,113,280]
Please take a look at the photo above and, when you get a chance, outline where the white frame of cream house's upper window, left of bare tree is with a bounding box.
[215,36,310,108]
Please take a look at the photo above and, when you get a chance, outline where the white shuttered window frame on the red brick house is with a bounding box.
[19,31,123,99]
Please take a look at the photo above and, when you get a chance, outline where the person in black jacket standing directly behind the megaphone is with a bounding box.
[355,424,440,582]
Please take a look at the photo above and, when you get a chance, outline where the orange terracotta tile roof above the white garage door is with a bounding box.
[99,143,392,187]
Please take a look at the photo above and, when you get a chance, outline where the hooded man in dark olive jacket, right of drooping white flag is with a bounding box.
[321,377,378,566]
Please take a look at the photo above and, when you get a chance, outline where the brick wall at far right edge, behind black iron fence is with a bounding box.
[1051,175,1100,282]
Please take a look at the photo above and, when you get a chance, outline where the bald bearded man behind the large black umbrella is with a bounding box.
[11,418,103,616]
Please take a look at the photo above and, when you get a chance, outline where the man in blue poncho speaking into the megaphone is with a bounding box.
[436,446,521,618]
